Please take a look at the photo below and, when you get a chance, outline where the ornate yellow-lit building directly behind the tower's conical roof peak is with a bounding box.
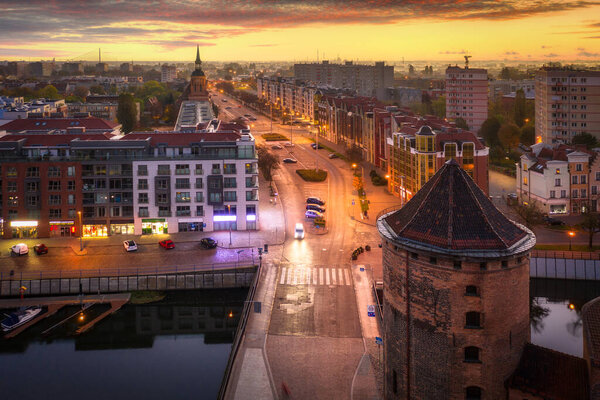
[387,115,489,204]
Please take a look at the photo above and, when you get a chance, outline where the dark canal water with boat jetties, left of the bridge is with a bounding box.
[0,289,247,400]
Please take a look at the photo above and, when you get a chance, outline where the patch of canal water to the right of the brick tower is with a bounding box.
[530,279,600,357]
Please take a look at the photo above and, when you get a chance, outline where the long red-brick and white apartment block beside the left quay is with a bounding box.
[0,124,259,238]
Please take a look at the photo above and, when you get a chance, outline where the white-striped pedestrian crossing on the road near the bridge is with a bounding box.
[278,266,352,286]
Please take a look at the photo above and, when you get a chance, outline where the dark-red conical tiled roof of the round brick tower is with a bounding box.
[377,160,535,256]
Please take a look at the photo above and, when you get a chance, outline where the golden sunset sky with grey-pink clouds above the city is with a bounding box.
[0,0,600,62]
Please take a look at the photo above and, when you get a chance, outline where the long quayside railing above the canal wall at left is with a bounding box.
[0,260,254,281]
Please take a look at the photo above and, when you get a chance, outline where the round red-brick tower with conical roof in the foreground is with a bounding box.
[377,160,535,399]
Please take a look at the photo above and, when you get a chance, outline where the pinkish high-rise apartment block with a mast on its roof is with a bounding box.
[446,66,488,132]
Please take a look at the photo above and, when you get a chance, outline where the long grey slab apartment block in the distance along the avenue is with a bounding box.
[294,61,394,97]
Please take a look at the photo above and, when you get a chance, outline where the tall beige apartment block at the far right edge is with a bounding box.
[535,67,600,144]
